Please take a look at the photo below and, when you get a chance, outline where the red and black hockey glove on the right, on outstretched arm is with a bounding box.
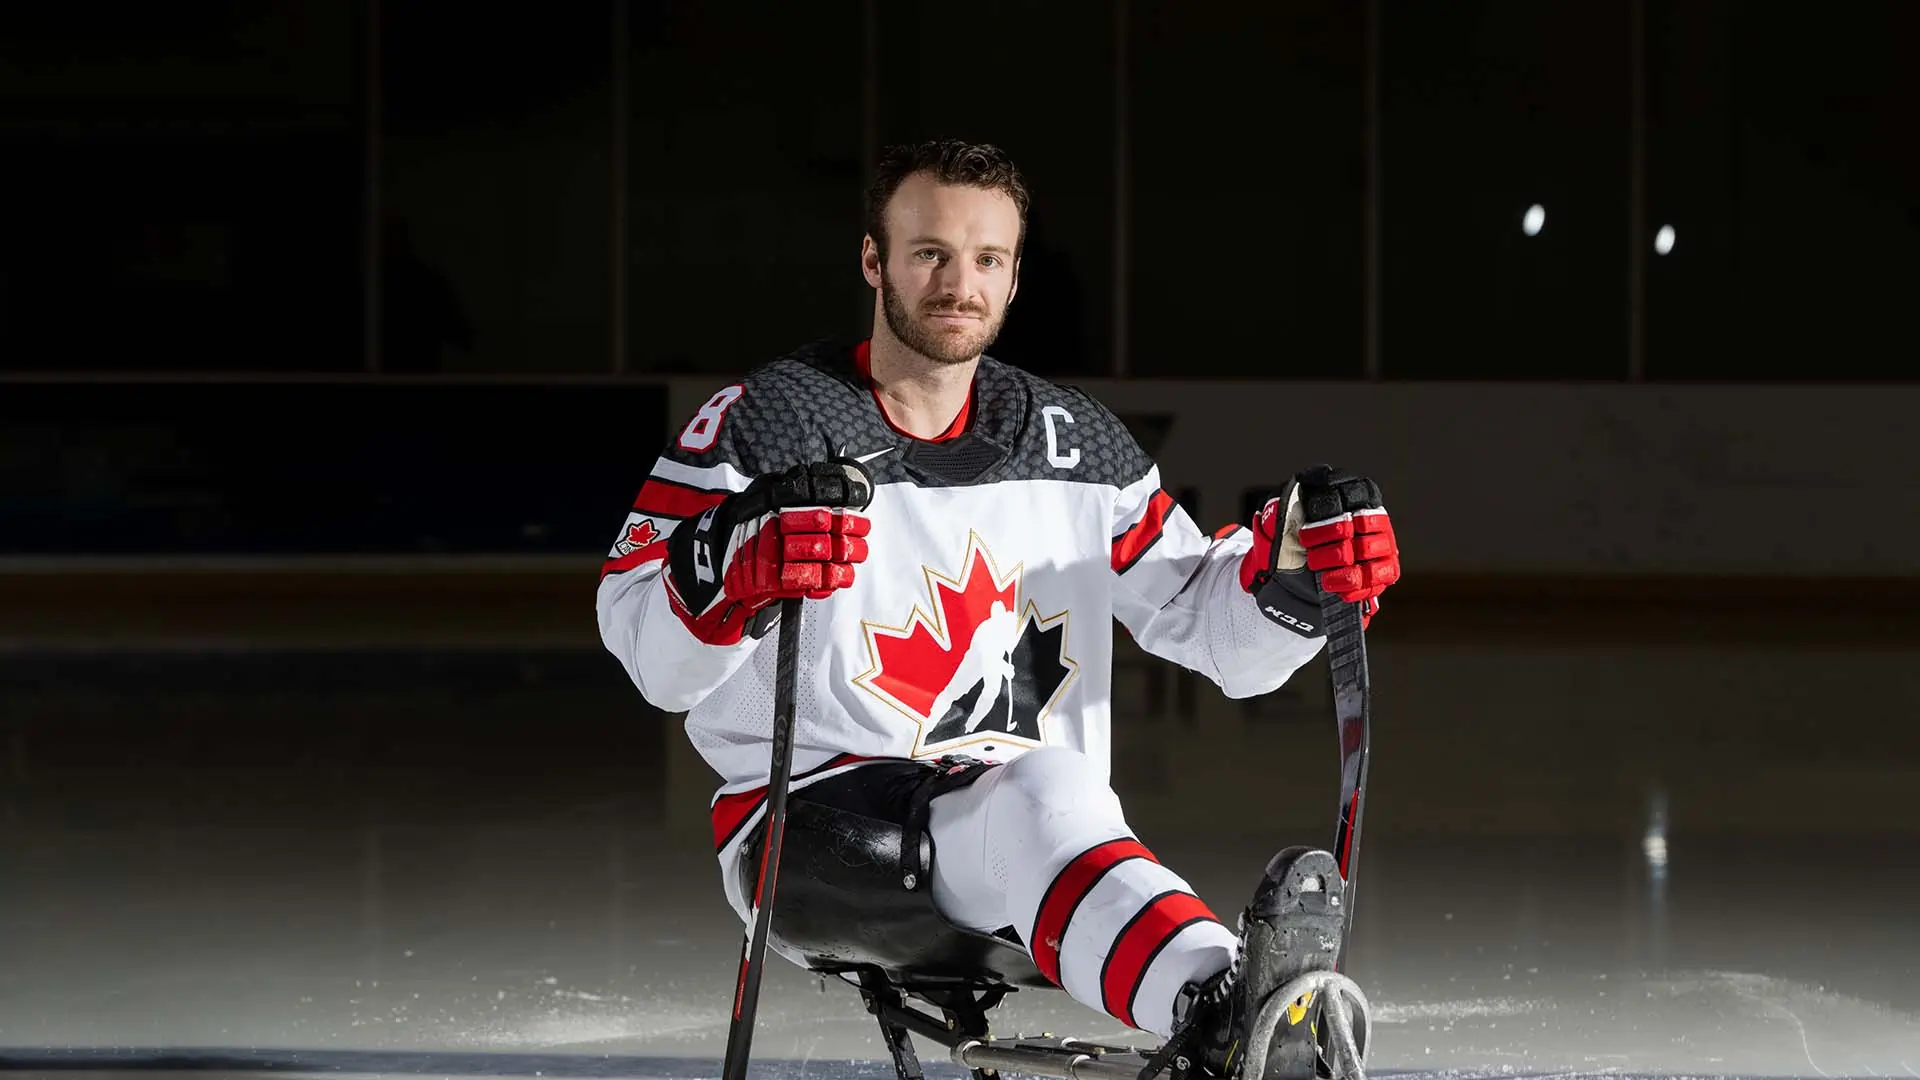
[1240,465,1400,636]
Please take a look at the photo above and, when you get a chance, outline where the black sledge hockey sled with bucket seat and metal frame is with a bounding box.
[737,799,1371,1080]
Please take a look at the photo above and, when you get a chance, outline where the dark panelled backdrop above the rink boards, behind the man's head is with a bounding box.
[0,0,1920,380]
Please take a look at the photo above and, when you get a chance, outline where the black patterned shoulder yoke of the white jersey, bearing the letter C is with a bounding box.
[741,340,1152,486]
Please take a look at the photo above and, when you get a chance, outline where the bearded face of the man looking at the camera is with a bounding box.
[862,173,1020,363]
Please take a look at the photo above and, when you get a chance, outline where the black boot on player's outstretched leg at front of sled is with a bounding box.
[1154,847,1371,1080]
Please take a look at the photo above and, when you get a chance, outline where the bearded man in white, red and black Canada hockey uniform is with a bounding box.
[599,140,1400,1076]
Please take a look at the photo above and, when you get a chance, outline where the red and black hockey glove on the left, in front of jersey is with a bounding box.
[664,459,874,646]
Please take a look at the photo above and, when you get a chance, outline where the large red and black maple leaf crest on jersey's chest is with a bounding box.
[854,532,1079,757]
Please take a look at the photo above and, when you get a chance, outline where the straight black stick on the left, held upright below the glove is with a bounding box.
[720,588,804,1080]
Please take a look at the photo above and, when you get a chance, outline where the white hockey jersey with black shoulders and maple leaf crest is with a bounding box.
[599,342,1323,868]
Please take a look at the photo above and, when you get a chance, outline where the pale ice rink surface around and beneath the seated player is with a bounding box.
[0,646,1920,1080]
